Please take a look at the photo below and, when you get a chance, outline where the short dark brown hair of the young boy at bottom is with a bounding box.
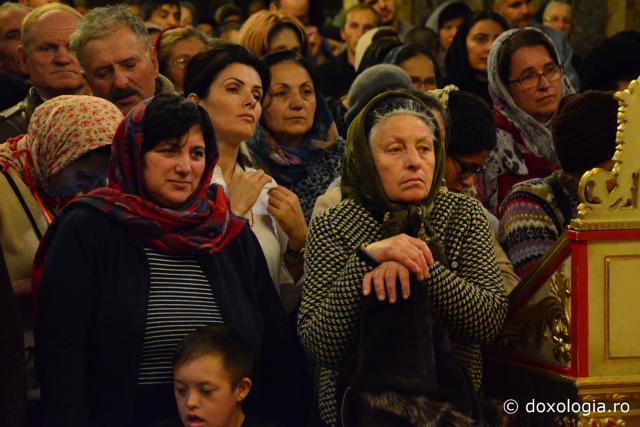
[173,325,253,388]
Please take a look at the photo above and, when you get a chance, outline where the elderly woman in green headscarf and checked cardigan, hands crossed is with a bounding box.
[298,92,507,425]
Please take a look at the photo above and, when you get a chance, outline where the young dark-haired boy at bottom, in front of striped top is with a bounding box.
[174,325,258,427]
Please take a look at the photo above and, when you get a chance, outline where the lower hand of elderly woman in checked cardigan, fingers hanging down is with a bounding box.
[362,261,411,304]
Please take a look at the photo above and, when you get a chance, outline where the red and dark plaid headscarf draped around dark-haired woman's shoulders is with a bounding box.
[33,95,245,298]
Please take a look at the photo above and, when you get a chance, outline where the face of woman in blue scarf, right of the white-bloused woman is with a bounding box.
[263,63,316,144]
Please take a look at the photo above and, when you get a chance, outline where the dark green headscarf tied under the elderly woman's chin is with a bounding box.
[341,91,446,265]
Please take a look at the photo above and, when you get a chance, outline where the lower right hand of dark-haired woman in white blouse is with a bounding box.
[267,186,307,251]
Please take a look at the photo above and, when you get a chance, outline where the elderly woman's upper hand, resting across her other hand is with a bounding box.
[365,233,433,280]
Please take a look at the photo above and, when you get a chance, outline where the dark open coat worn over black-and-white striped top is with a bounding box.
[36,206,303,427]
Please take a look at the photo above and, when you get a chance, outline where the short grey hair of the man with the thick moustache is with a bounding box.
[71,5,151,62]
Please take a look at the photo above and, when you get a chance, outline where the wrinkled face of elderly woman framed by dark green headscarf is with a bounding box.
[369,114,436,203]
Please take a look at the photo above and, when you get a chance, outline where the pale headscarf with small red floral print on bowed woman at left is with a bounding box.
[0,95,122,209]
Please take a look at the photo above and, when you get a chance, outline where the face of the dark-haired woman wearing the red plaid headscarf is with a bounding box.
[142,125,205,209]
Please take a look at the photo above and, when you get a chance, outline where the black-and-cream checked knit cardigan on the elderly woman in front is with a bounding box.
[298,191,507,425]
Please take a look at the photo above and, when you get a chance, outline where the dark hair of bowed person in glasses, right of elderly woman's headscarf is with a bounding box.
[447,90,496,156]
